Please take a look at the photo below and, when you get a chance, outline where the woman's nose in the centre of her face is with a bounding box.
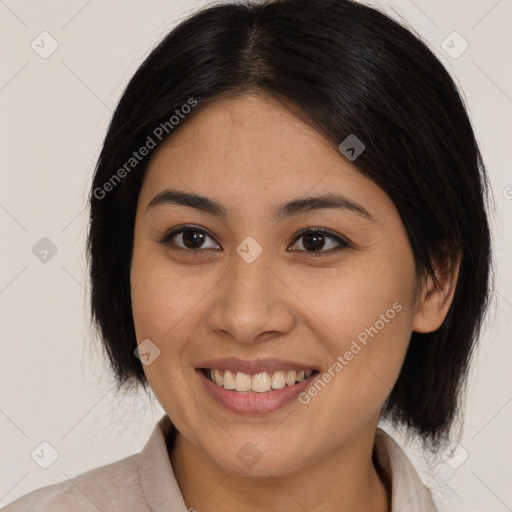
[207,244,295,344]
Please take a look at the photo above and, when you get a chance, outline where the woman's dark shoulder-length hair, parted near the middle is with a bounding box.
[88,0,491,445]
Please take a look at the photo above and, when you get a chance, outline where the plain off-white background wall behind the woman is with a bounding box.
[0,0,512,512]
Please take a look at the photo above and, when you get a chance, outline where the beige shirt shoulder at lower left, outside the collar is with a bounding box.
[2,453,146,512]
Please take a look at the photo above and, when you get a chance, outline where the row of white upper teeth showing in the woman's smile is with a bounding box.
[201,368,318,393]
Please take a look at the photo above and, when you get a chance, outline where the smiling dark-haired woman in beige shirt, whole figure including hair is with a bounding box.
[5,0,490,512]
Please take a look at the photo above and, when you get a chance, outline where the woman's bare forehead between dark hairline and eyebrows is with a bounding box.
[144,93,378,204]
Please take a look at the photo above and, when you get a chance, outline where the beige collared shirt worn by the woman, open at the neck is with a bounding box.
[2,415,436,512]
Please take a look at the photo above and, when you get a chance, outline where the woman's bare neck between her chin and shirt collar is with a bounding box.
[170,429,391,512]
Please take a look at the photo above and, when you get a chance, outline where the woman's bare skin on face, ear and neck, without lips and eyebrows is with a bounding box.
[131,92,457,512]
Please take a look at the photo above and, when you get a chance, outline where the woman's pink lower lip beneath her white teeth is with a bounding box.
[196,370,315,415]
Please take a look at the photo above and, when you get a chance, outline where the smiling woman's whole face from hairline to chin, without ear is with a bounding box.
[131,91,415,475]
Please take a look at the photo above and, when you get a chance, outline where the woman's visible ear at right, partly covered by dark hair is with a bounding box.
[412,251,461,333]
